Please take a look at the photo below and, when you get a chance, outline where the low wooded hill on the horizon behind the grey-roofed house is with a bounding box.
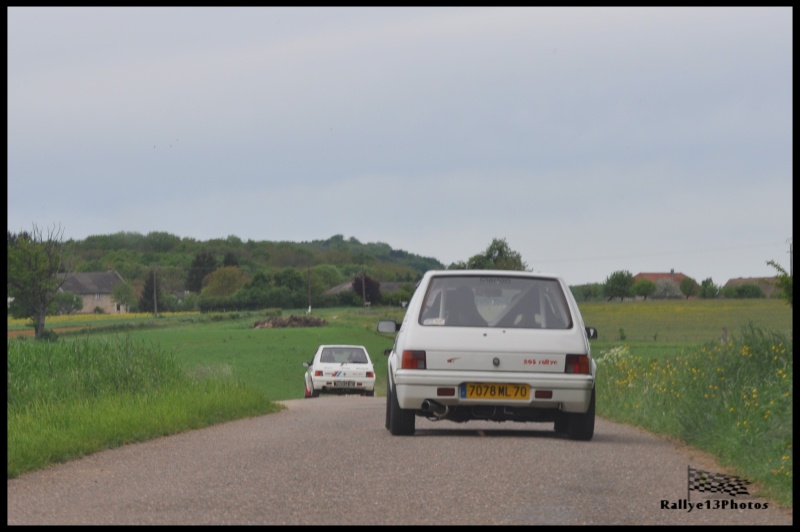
[64,232,445,302]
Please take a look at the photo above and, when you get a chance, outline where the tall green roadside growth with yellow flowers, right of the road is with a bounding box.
[596,323,793,503]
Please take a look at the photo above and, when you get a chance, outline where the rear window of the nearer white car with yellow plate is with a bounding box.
[419,274,572,329]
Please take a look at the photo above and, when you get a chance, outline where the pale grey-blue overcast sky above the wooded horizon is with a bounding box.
[7,7,793,285]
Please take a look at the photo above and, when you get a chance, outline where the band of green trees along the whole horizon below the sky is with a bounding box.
[7,225,791,338]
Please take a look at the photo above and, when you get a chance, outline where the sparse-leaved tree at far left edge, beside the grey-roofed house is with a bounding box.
[6,224,66,338]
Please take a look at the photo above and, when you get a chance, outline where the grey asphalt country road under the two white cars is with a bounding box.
[8,396,792,525]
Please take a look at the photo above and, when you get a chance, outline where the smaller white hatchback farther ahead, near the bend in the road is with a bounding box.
[303,345,375,397]
